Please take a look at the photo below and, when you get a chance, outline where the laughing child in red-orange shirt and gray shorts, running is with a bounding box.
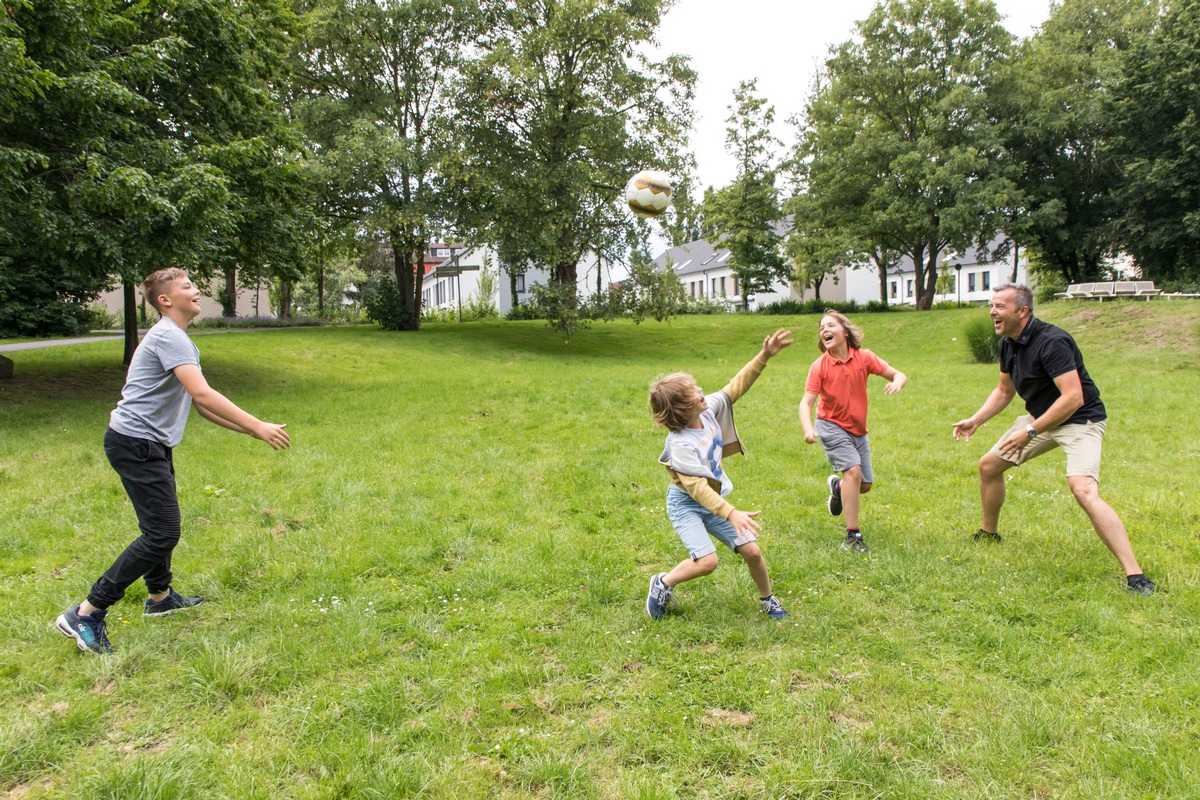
[800,311,908,553]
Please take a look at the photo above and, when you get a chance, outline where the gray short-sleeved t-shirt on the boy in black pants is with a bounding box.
[108,317,200,447]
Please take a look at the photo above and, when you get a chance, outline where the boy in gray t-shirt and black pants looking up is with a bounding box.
[54,269,292,654]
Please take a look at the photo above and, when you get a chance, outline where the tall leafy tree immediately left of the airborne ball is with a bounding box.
[452,0,695,328]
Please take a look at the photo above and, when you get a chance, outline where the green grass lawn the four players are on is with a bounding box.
[0,301,1200,800]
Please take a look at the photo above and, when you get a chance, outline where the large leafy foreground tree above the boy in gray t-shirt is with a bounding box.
[0,0,304,361]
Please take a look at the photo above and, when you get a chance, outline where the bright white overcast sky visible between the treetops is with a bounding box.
[659,0,1050,191]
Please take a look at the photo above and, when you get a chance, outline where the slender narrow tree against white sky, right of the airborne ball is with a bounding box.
[704,80,790,309]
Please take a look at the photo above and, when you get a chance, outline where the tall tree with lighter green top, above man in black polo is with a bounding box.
[998,0,1158,283]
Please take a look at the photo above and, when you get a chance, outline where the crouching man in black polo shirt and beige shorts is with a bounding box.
[954,284,1154,595]
